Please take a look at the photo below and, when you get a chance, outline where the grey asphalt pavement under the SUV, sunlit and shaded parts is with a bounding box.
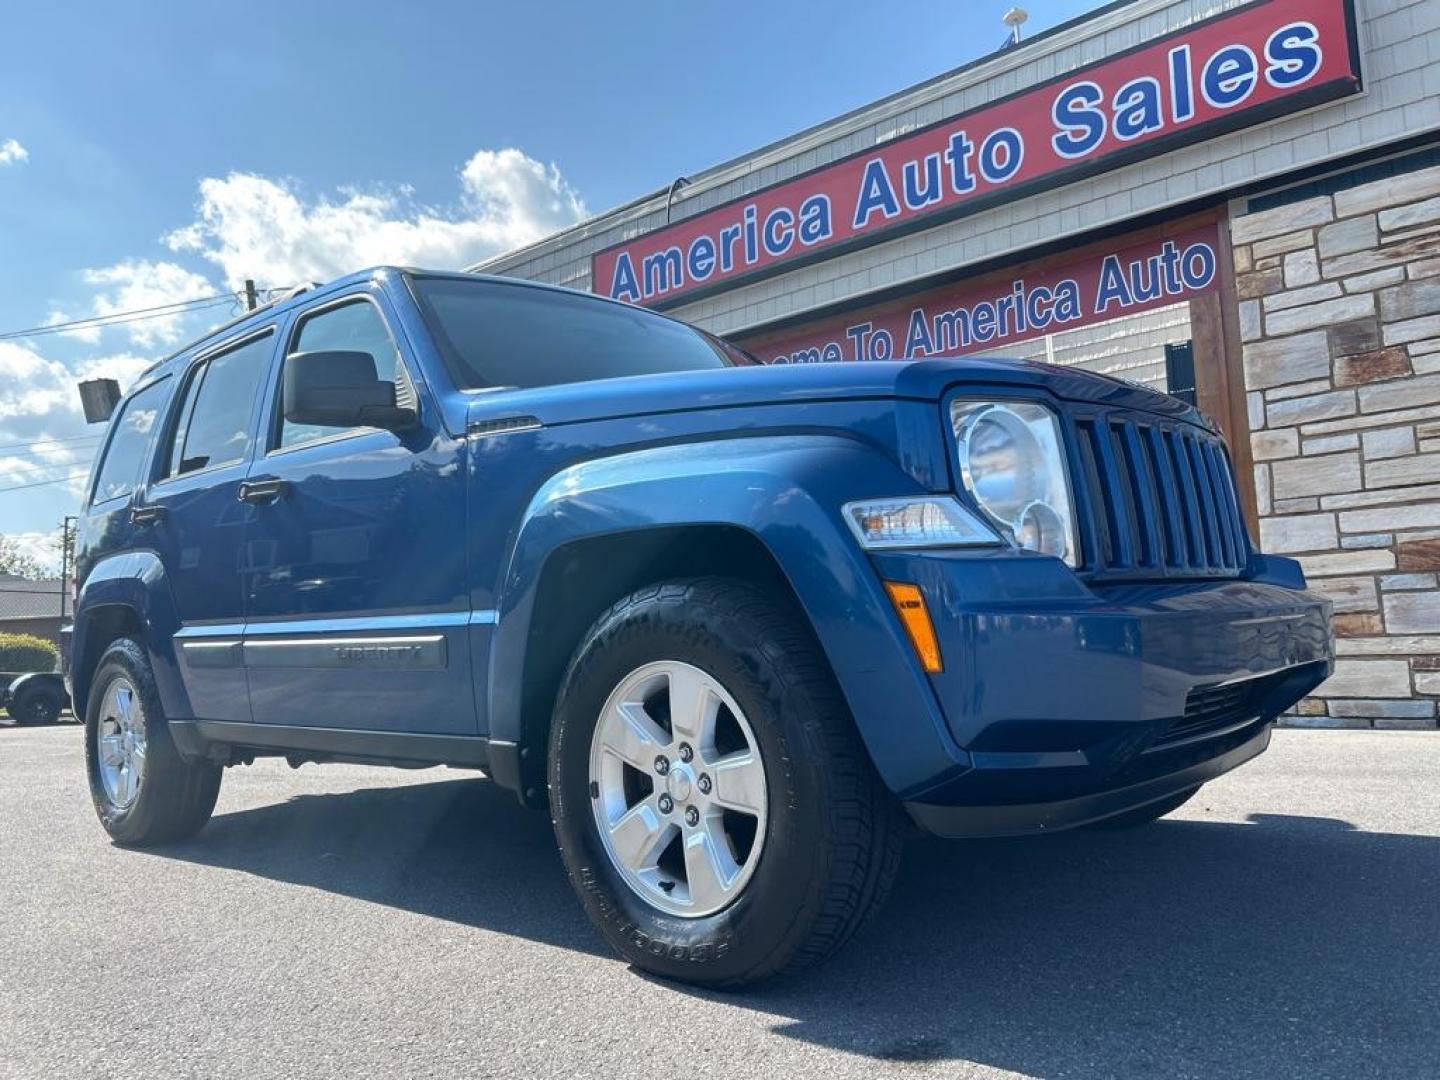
[0,724,1440,1080]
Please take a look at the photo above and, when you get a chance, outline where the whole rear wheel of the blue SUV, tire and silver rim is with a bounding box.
[85,638,222,847]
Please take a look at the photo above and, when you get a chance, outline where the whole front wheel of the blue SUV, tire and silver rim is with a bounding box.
[550,579,900,986]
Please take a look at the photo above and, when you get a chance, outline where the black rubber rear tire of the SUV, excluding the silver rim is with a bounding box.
[85,638,223,847]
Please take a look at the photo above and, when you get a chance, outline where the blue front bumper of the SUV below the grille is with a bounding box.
[876,553,1332,837]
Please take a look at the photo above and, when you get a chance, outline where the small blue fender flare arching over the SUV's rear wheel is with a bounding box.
[71,550,190,717]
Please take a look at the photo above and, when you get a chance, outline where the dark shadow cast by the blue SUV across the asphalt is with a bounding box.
[151,779,1440,1079]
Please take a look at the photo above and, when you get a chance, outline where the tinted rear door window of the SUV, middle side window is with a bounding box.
[166,334,274,477]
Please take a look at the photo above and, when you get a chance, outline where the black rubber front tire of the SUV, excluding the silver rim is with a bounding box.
[549,577,903,986]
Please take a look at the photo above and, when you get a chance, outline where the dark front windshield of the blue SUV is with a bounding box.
[410,276,755,390]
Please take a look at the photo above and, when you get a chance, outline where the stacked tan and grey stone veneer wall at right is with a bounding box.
[1231,168,1440,729]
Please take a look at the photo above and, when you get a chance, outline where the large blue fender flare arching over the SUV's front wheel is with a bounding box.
[487,433,969,795]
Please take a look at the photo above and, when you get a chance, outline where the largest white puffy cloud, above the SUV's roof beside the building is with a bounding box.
[166,148,586,288]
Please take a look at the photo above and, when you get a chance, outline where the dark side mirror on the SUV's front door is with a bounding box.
[282,350,415,431]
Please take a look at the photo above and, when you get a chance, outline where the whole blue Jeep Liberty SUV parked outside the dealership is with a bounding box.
[66,268,1332,985]
